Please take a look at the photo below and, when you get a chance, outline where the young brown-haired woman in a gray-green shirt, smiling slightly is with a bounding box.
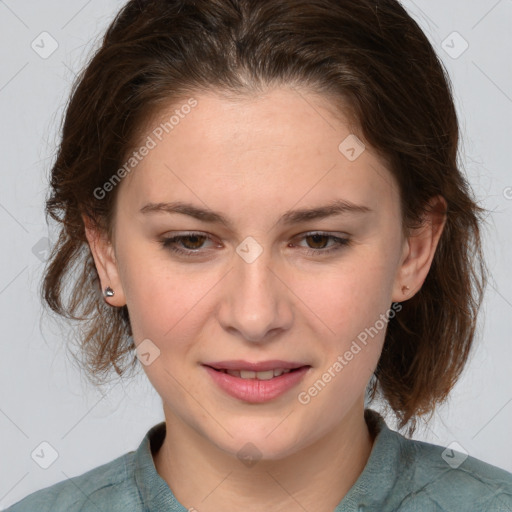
[5,0,512,512]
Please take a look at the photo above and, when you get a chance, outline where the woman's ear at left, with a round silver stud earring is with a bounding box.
[82,215,126,307]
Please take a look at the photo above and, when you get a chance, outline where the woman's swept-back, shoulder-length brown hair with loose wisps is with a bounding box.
[43,0,487,432]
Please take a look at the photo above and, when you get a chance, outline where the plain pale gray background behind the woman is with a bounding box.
[0,0,512,510]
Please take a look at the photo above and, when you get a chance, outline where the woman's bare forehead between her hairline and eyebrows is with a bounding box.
[117,88,397,220]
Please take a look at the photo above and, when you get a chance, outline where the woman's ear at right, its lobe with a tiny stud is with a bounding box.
[392,196,447,302]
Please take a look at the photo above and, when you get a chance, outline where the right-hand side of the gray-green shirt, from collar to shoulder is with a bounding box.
[358,409,512,512]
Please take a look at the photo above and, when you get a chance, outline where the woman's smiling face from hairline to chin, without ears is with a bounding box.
[99,88,410,459]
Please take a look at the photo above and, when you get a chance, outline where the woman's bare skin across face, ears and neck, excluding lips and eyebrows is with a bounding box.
[84,87,444,512]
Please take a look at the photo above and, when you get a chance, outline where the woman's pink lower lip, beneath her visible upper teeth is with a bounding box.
[204,366,311,403]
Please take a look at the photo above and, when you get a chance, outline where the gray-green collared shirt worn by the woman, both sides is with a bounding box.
[7,409,512,512]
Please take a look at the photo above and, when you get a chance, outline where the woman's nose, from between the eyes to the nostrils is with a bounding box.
[218,251,293,344]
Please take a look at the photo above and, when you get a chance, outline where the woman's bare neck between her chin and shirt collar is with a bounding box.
[154,404,373,512]
